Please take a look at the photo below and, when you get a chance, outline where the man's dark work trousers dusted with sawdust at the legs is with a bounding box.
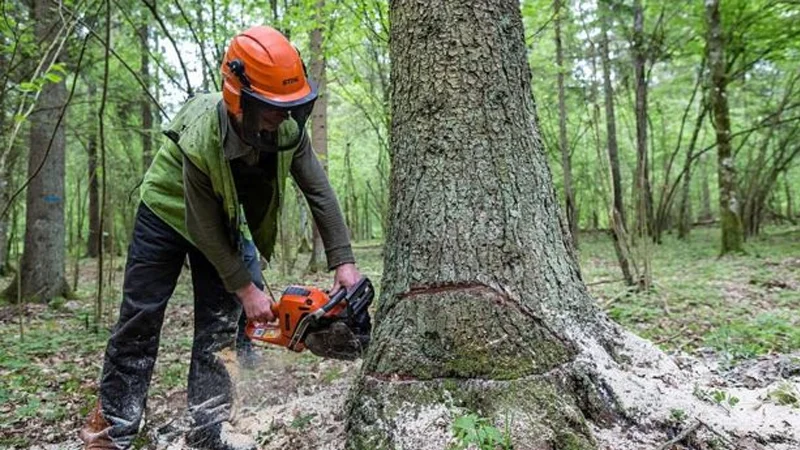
[100,204,262,448]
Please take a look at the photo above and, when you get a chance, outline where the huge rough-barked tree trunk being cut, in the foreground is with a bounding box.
[347,0,628,449]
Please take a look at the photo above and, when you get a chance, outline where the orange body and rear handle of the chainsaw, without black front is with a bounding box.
[245,286,345,352]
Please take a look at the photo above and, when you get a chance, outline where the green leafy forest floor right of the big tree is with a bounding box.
[580,227,800,362]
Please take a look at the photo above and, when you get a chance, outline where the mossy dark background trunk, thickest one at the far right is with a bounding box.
[706,0,744,255]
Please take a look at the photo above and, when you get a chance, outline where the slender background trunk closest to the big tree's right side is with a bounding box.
[553,0,578,248]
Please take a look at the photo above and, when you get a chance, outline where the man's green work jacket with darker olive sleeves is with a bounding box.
[141,93,354,290]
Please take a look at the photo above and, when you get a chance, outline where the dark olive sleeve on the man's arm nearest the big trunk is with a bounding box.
[291,133,355,269]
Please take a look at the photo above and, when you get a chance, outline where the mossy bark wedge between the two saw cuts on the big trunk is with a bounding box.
[365,288,575,380]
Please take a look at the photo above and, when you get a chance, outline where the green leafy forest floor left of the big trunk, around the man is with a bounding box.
[0,246,383,448]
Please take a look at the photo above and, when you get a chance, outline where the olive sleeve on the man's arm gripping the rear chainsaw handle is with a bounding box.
[183,156,251,292]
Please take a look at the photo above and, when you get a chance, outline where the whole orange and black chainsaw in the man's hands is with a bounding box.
[245,277,375,360]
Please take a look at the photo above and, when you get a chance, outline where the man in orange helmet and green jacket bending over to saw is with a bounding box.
[80,26,360,450]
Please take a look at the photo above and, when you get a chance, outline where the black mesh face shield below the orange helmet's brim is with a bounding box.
[241,87,316,152]
